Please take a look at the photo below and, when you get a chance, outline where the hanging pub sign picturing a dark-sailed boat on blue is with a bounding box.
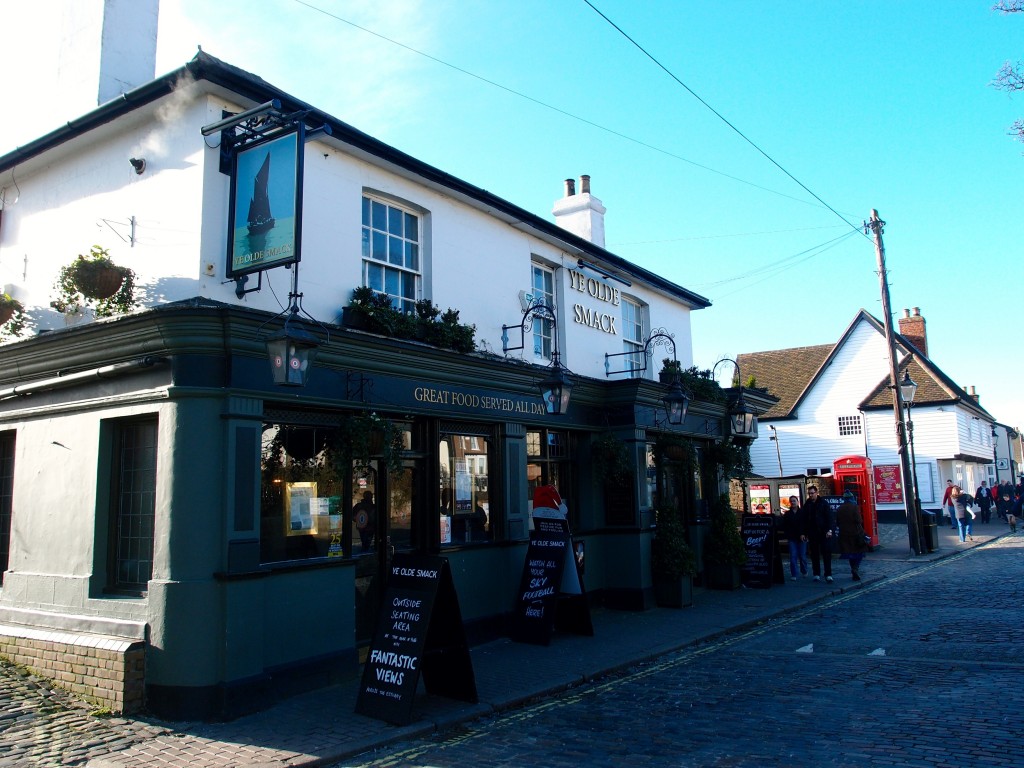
[226,124,305,279]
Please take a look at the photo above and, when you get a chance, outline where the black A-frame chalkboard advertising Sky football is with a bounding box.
[511,517,594,645]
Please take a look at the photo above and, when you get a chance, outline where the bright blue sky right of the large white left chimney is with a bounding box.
[0,0,1024,426]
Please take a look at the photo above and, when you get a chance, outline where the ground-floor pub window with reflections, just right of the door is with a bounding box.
[437,434,494,547]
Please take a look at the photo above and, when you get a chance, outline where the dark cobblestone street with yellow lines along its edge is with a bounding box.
[339,538,1024,768]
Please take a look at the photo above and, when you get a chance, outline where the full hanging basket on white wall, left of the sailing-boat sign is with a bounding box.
[50,246,138,317]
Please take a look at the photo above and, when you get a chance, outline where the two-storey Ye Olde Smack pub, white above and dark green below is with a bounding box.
[0,43,770,718]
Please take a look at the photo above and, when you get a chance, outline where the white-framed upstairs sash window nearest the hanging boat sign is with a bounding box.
[362,196,423,312]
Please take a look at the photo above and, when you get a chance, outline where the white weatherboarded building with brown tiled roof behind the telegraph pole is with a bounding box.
[738,308,1006,521]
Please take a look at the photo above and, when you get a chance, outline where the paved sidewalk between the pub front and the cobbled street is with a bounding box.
[0,521,1009,768]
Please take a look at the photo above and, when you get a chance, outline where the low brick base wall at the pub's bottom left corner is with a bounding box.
[0,625,145,715]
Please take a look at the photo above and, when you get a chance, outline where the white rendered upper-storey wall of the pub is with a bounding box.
[0,86,692,379]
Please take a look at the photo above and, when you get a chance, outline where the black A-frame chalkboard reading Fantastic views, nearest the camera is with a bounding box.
[355,553,477,725]
